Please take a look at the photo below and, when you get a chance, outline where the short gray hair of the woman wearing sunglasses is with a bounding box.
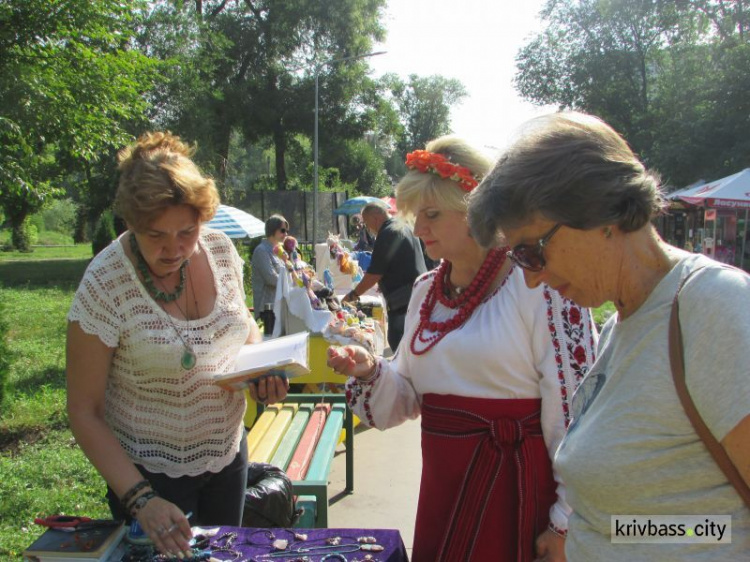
[469,112,664,246]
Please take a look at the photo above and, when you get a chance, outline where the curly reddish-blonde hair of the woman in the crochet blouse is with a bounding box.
[114,131,219,232]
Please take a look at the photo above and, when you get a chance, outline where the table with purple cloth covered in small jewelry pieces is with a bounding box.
[181,527,409,562]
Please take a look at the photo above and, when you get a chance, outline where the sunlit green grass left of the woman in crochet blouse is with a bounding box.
[0,280,109,560]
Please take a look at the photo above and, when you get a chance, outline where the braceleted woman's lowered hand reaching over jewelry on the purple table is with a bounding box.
[136,497,193,558]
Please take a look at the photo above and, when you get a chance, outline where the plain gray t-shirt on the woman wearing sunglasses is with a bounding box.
[555,255,750,562]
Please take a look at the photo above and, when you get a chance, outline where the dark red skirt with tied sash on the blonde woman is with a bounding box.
[412,394,557,562]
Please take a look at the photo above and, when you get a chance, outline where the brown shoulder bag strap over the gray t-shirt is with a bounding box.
[669,267,750,508]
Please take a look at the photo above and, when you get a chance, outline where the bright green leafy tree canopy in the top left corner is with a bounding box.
[0,0,164,245]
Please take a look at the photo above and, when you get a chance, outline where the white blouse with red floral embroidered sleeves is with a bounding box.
[347,266,597,530]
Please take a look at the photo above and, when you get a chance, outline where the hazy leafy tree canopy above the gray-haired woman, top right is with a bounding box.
[516,0,750,186]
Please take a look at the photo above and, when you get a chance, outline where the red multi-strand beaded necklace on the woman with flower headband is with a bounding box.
[411,248,508,355]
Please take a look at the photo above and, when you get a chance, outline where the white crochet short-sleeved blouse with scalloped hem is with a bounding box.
[68,227,250,478]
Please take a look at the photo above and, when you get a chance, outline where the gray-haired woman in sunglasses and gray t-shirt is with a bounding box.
[469,112,750,562]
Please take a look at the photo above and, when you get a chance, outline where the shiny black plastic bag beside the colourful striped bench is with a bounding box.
[242,462,302,528]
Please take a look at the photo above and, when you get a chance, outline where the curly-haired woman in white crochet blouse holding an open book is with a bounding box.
[67,132,286,556]
